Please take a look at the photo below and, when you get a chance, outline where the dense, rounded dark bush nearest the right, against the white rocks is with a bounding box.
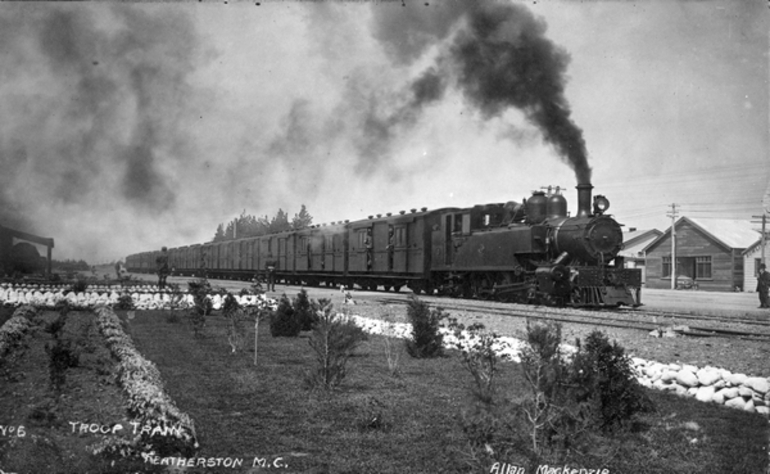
[568,331,652,431]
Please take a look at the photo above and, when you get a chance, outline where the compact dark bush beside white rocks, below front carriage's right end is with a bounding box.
[406,296,447,359]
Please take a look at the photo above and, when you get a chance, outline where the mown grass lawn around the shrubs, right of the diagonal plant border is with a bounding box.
[119,311,768,473]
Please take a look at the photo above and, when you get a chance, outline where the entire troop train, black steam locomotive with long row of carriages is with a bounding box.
[126,184,641,307]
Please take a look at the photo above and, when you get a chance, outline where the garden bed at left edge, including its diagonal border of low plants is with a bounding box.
[0,305,199,473]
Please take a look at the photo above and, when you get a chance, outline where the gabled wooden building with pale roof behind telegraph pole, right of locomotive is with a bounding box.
[645,217,759,291]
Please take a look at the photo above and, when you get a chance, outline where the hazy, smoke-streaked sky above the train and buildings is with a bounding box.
[0,0,770,263]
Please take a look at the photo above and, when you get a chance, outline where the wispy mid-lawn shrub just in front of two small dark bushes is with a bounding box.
[308,303,367,389]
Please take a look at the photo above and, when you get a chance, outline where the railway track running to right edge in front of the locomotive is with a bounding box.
[374,297,770,341]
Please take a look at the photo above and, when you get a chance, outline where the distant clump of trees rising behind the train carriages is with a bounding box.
[214,204,313,242]
